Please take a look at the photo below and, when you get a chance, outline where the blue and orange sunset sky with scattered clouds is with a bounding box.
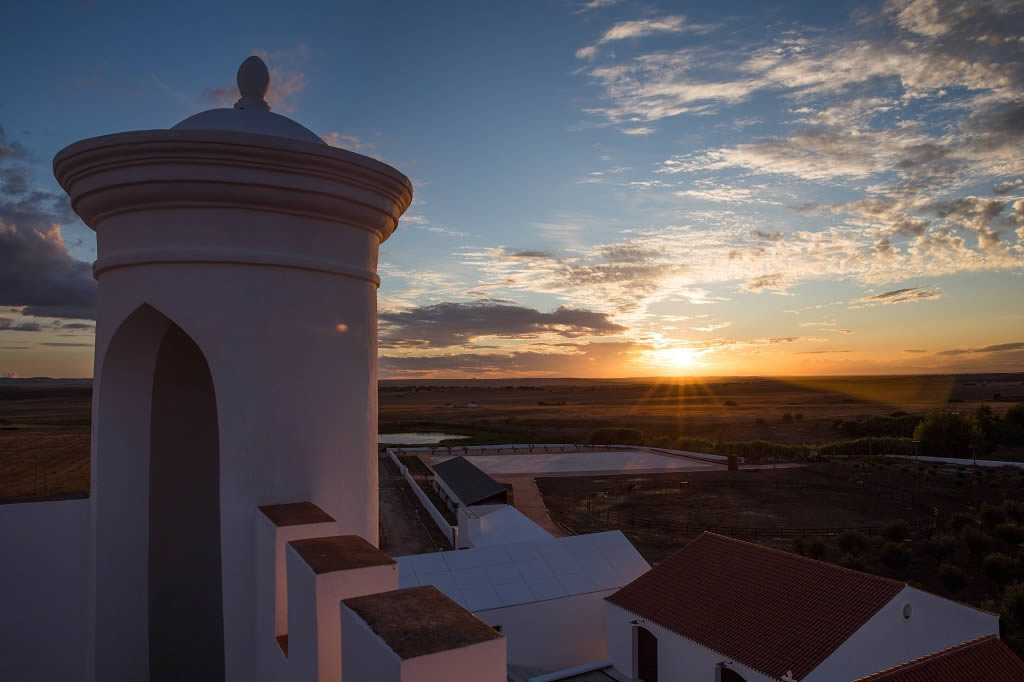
[0,0,1024,378]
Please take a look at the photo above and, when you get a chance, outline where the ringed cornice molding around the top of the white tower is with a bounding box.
[53,130,413,242]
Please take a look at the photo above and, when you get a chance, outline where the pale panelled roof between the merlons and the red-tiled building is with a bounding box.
[396,530,650,611]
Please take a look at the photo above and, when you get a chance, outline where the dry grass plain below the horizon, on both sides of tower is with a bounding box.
[0,374,1024,502]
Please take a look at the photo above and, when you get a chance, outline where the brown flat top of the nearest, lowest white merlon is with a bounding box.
[341,585,502,660]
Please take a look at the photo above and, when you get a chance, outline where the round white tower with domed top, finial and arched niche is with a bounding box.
[53,57,413,680]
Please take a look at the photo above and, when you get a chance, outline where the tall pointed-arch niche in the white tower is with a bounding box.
[93,305,224,682]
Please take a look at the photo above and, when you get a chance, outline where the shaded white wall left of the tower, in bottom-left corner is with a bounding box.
[0,493,89,682]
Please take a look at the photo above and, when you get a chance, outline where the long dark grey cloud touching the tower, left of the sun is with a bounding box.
[378,300,627,348]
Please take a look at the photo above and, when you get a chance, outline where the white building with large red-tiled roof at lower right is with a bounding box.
[606,532,995,682]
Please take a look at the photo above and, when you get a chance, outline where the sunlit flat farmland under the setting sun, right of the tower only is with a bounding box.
[380,374,1024,443]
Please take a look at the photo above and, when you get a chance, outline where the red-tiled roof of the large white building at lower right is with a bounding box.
[607,532,904,680]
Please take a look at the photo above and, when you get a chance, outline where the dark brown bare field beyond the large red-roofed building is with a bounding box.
[537,458,1024,561]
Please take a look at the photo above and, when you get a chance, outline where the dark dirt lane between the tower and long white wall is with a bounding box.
[378,457,452,556]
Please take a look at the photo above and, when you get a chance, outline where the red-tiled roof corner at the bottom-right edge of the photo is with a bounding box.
[856,635,1024,682]
